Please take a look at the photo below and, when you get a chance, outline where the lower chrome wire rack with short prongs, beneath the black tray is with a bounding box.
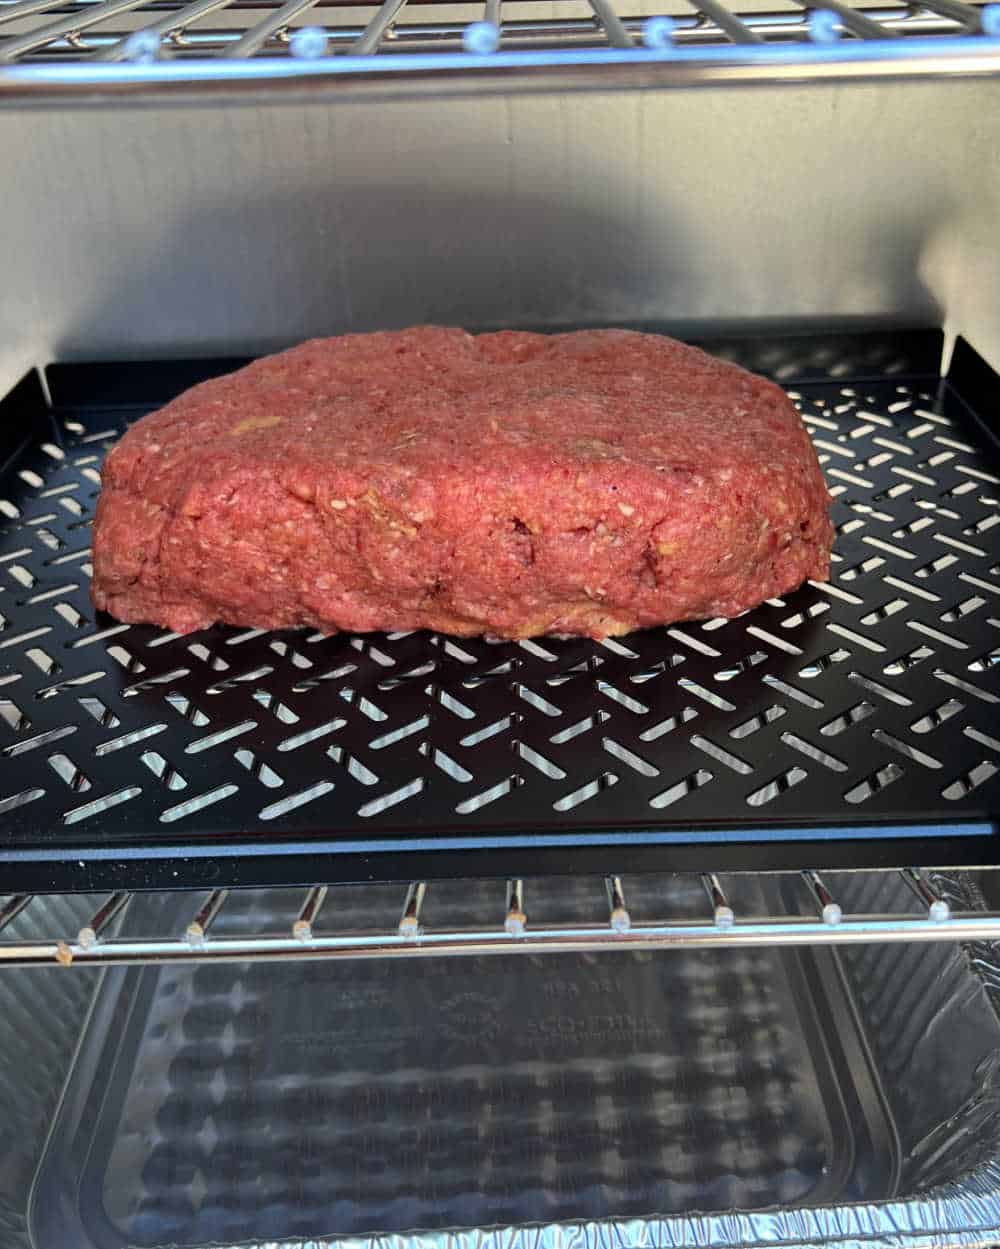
[0,869,1000,968]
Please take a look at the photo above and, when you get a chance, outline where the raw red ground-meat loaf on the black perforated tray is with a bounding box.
[94,327,833,638]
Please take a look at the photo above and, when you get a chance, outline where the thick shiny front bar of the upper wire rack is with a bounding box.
[0,35,1000,105]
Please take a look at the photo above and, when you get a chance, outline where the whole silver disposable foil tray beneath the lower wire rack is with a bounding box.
[0,873,1000,1249]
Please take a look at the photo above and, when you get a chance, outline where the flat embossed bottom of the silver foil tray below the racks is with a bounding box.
[29,879,903,1249]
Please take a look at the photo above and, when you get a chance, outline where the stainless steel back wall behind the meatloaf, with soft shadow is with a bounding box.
[0,79,1000,390]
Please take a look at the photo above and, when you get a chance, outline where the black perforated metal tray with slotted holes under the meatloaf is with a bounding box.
[0,332,1000,891]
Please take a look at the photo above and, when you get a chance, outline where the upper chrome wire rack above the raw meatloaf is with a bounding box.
[0,0,1000,99]
